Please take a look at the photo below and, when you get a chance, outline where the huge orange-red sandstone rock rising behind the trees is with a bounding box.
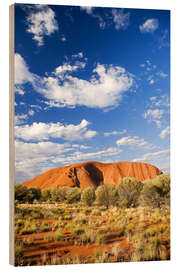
[23,161,162,189]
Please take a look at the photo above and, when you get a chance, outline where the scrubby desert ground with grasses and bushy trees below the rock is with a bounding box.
[14,175,170,266]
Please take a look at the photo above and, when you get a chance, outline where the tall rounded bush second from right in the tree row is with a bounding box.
[117,177,143,208]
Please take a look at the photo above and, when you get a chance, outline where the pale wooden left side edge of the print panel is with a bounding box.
[9,5,15,265]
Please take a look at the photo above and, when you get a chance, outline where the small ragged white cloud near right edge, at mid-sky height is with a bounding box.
[143,109,164,127]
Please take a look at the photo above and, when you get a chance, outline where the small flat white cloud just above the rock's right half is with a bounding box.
[116,136,155,149]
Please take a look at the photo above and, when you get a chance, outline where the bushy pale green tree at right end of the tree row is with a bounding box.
[140,174,170,208]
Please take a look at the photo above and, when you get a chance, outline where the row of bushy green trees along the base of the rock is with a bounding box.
[15,174,170,208]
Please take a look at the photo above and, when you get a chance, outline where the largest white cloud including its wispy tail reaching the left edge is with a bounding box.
[15,55,134,109]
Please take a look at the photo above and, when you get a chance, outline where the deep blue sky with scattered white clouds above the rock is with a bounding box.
[14,4,170,183]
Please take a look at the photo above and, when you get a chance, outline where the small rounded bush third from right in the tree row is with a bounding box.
[96,185,117,208]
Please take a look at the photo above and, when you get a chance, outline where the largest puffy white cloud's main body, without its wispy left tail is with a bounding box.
[38,64,134,108]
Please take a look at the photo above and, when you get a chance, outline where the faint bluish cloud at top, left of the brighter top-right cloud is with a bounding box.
[112,8,130,30]
